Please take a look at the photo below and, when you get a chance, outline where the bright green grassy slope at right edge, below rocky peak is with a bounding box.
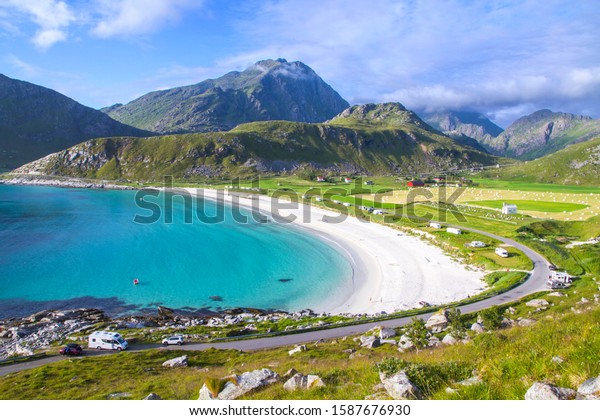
[488,137,600,186]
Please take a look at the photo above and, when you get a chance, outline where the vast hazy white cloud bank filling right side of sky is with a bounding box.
[229,0,600,124]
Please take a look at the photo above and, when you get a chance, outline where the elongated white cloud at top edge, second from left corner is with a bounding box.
[92,0,203,38]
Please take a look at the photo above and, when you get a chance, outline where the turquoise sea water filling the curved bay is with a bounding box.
[0,185,352,318]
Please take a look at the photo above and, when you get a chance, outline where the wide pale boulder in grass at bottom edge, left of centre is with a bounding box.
[198,369,279,400]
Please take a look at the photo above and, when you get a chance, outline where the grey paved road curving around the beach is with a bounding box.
[0,226,550,376]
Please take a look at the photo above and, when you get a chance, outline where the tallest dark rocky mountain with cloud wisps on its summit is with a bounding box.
[102,59,348,134]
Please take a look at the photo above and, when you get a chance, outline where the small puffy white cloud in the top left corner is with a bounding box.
[3,0,75,49]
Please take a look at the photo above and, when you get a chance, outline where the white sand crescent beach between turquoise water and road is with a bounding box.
[180,188,485,314]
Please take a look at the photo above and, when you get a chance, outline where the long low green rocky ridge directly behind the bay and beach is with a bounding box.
[18,104,497,180]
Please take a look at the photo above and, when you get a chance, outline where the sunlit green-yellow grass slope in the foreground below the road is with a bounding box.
[0,277,600,399]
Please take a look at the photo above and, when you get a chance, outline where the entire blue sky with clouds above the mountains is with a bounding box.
[0,0,600,127]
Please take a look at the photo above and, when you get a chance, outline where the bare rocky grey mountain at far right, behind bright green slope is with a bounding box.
[481,109,600,160]
